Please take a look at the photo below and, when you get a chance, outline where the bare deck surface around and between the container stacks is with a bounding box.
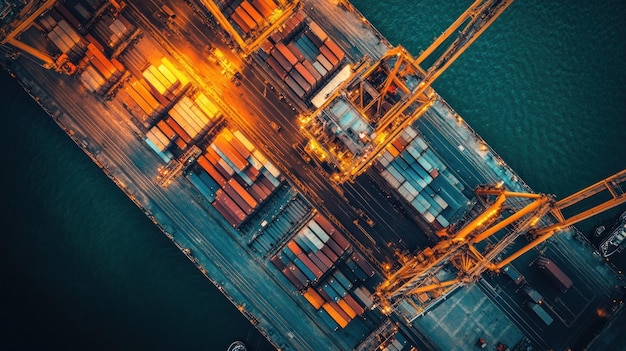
[2,0,619,350]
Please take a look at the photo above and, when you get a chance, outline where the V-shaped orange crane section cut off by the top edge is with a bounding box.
[201,0,299,57]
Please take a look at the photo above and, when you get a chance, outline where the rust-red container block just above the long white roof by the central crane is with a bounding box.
[258,12,345,100]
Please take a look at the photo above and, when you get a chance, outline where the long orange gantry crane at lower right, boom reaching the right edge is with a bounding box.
[376,170,626,320]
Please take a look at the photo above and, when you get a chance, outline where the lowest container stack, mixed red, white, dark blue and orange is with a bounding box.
[270,214,375,329]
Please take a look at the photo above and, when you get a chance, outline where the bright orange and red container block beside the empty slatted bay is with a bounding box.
[192,128,282,228]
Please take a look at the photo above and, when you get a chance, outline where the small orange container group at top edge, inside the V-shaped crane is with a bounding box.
[227,0,277,36]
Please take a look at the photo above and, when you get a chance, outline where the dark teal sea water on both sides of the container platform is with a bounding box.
[0,0,626,350]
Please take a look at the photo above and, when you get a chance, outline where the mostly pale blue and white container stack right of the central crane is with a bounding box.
[374,126,465,230]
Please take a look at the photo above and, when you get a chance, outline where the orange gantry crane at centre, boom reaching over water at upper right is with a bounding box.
[303,0,513,182]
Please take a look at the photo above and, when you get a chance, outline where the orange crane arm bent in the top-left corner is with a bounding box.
[1,0,76,75]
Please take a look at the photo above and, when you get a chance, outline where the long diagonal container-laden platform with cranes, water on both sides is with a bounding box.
[2,0,623,351]
